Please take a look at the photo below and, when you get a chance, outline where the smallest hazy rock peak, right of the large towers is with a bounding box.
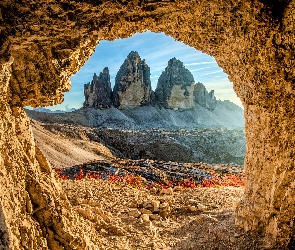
[194,82,217,111]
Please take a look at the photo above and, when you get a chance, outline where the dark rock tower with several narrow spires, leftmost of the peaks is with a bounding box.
[83,67,112,109]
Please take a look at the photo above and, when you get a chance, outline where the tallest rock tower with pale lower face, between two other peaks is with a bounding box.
[113,51,151,109]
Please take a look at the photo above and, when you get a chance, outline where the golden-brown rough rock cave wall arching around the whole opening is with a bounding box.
[0,0,295,249]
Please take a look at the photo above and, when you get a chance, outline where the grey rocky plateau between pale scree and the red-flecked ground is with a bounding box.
[93,128,246,165]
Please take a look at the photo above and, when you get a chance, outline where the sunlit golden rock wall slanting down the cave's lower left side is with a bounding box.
[0,60,102,250]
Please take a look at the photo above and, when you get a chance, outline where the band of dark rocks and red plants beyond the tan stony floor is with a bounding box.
[55,159,245,186]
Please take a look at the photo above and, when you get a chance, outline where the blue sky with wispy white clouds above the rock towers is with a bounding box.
[48,31,242,110]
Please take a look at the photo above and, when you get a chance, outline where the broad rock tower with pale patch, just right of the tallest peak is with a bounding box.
[155,57,194,110]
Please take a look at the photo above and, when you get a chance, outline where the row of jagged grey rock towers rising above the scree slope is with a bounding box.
[83,51,222,111]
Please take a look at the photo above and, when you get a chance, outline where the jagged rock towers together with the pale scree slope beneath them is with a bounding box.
[28,51,244,130]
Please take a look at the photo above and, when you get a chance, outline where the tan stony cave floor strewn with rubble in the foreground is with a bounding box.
[61,173,264,250]
